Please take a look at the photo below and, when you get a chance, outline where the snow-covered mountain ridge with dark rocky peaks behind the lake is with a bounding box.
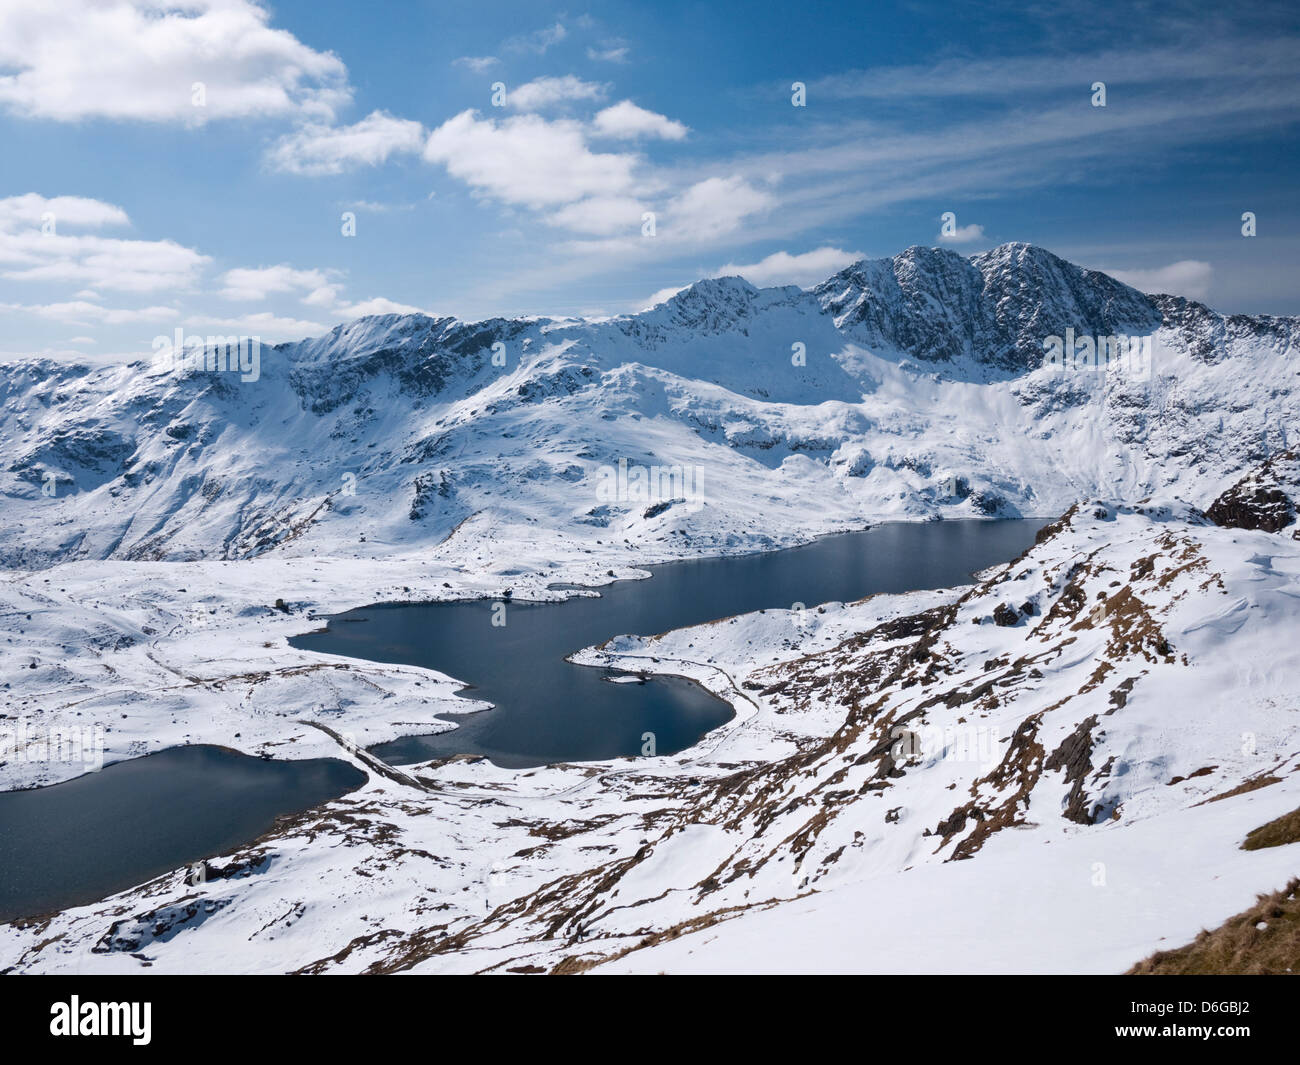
[0,244,1300,568]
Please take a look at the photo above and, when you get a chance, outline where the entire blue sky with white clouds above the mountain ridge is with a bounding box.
[0,0,1300,358]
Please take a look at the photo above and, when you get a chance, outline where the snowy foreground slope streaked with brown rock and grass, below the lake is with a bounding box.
[0,478,1300,973]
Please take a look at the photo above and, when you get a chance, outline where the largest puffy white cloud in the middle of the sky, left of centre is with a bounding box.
[424,111,636,208]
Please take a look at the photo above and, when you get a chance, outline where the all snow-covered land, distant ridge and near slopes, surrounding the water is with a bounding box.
[0,244,1300,973]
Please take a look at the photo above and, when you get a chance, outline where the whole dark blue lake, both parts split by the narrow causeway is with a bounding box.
[0,520,1043,921]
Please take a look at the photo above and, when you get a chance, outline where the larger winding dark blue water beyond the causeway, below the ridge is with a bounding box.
[290,520,1044,767]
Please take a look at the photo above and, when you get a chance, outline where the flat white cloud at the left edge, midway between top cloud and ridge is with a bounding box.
[0,192,209,293]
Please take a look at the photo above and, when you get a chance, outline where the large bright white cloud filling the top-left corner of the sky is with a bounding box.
[0,0,350,122]
